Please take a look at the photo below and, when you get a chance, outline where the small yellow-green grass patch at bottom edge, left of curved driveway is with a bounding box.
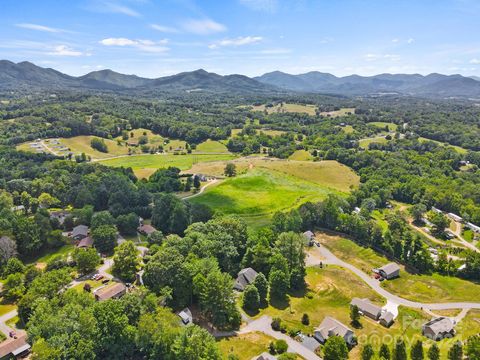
[218,332,275,360]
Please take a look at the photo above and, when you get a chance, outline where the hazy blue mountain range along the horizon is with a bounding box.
[0,60,480,98]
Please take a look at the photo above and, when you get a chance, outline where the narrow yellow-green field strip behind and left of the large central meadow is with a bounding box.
[100,153,235,178]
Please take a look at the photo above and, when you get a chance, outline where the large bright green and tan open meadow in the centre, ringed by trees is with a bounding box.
[189,159,357,226]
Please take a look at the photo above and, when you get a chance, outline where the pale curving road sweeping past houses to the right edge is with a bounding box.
[315,245,480,310]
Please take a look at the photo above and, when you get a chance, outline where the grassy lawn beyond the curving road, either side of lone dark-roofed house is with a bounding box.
[317,232,480,303]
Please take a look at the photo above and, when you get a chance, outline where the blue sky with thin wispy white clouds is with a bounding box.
[0,0,480,77]
